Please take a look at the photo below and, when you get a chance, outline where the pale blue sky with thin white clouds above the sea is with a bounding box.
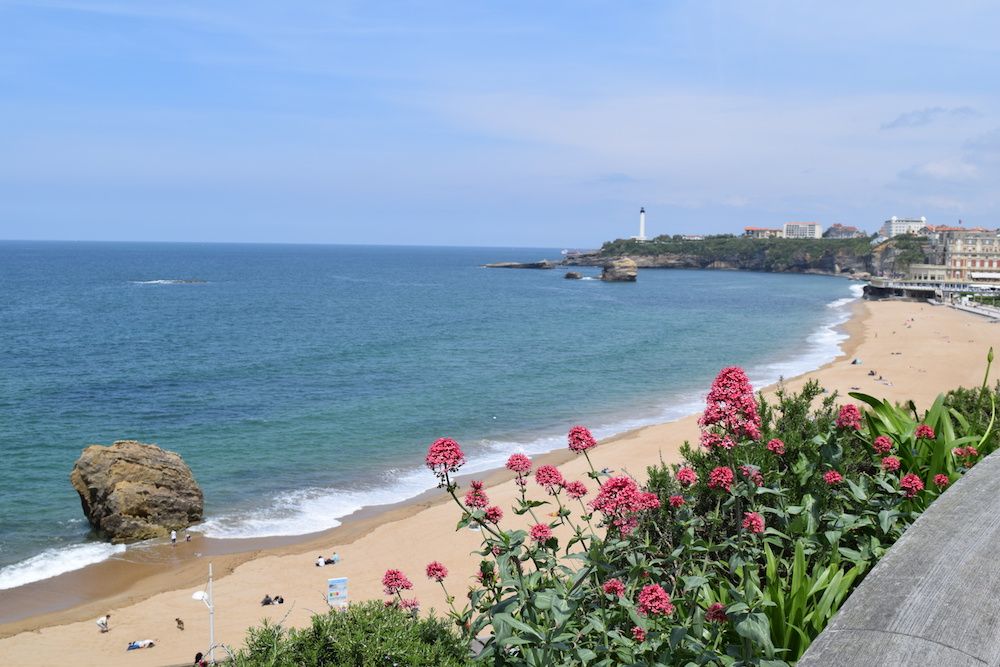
[0,0,1000,248]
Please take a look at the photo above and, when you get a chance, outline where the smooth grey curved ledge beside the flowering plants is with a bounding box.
[798,451,1000,667]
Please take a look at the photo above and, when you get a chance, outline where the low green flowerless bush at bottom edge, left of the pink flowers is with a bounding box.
[233,601,470,667]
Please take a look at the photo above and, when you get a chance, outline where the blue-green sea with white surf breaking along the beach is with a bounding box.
[0,242,857,589]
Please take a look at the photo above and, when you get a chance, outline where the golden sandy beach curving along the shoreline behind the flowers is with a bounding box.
[0,302,1000,665]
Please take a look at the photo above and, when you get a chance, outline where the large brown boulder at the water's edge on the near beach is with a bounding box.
[69,440,205,542]
